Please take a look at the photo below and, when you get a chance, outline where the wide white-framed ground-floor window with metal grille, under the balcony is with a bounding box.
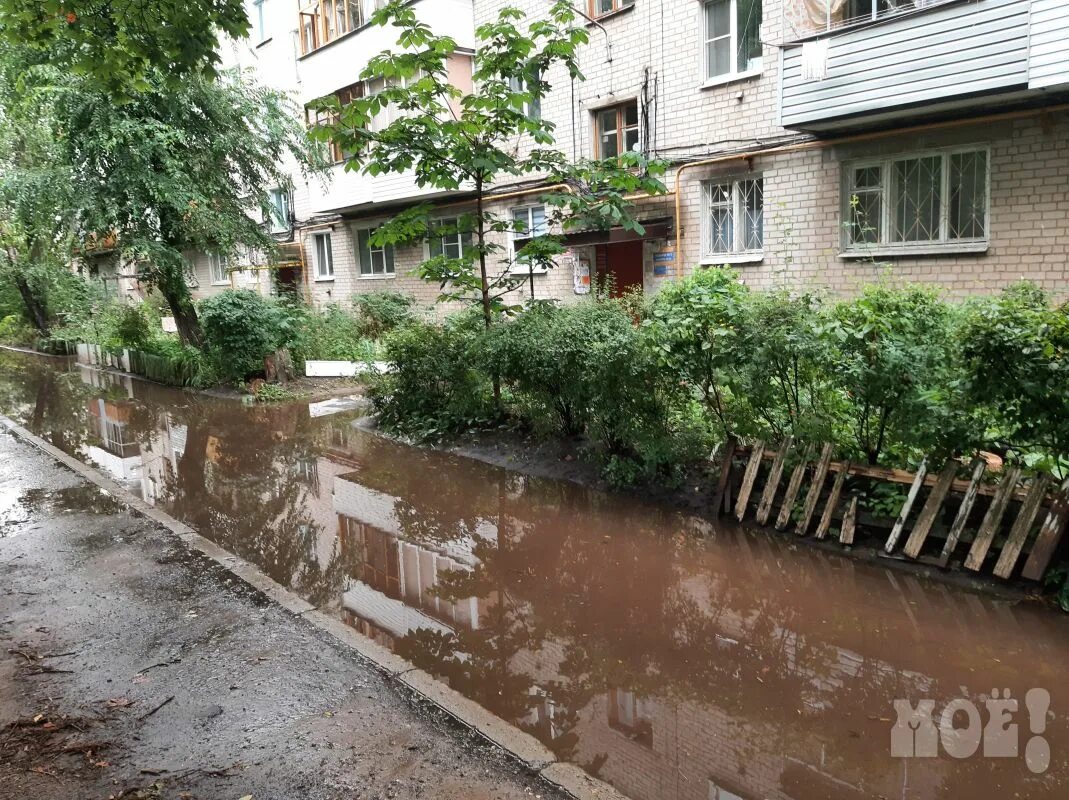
[843,150,989,250]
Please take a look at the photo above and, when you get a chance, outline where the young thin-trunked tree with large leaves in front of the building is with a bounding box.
[313,0,665,327]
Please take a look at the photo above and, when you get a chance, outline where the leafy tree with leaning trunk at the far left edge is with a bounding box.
[0,47,77,336]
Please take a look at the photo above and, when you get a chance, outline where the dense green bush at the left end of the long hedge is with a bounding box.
[368,312,495,439]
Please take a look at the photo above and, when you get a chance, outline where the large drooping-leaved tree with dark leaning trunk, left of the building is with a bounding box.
[60,71,319,347]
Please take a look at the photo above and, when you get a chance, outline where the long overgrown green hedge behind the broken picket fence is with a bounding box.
[371,270,1069,489]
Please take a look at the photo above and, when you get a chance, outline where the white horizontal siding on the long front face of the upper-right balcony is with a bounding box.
[781,0,1029,127]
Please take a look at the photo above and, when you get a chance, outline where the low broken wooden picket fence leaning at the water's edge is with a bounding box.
[713,437,1069,581]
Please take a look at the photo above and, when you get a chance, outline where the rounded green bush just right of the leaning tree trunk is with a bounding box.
[199,289,283,383]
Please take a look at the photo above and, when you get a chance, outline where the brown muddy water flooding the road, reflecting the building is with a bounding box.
[0,353,1069,800]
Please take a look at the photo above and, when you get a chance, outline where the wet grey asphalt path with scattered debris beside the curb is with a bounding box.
[0,432,558,800]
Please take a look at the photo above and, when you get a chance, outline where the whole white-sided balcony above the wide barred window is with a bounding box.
[779,0,1069,133]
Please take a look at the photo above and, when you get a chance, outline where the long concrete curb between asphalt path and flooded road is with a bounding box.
[0,414,626,800]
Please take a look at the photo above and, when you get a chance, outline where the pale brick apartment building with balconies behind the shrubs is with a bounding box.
[196,0,1069,304]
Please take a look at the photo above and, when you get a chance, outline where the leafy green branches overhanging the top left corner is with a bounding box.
[0,0,249,99]
